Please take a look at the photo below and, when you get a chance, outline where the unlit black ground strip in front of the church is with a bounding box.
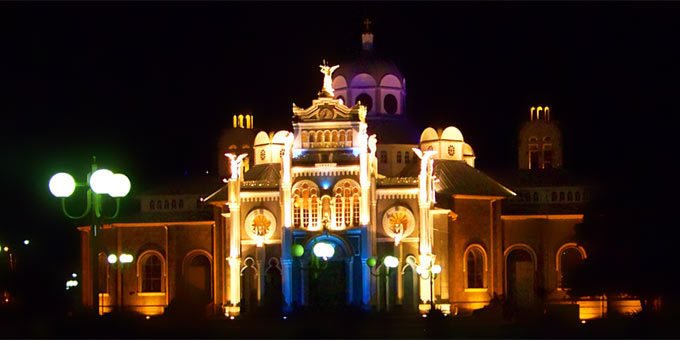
[0,310,680,338]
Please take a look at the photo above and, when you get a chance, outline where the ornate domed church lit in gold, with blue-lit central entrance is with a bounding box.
[81,23,636,317]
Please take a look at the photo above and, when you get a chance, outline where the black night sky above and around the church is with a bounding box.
[0,2,680,284]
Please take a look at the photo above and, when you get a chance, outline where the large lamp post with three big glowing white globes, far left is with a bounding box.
[49,157,130,313]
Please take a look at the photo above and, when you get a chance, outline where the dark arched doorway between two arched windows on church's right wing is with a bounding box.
[506,248,537,308]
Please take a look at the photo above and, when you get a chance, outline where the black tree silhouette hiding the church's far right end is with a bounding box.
[565,166,678,312]
